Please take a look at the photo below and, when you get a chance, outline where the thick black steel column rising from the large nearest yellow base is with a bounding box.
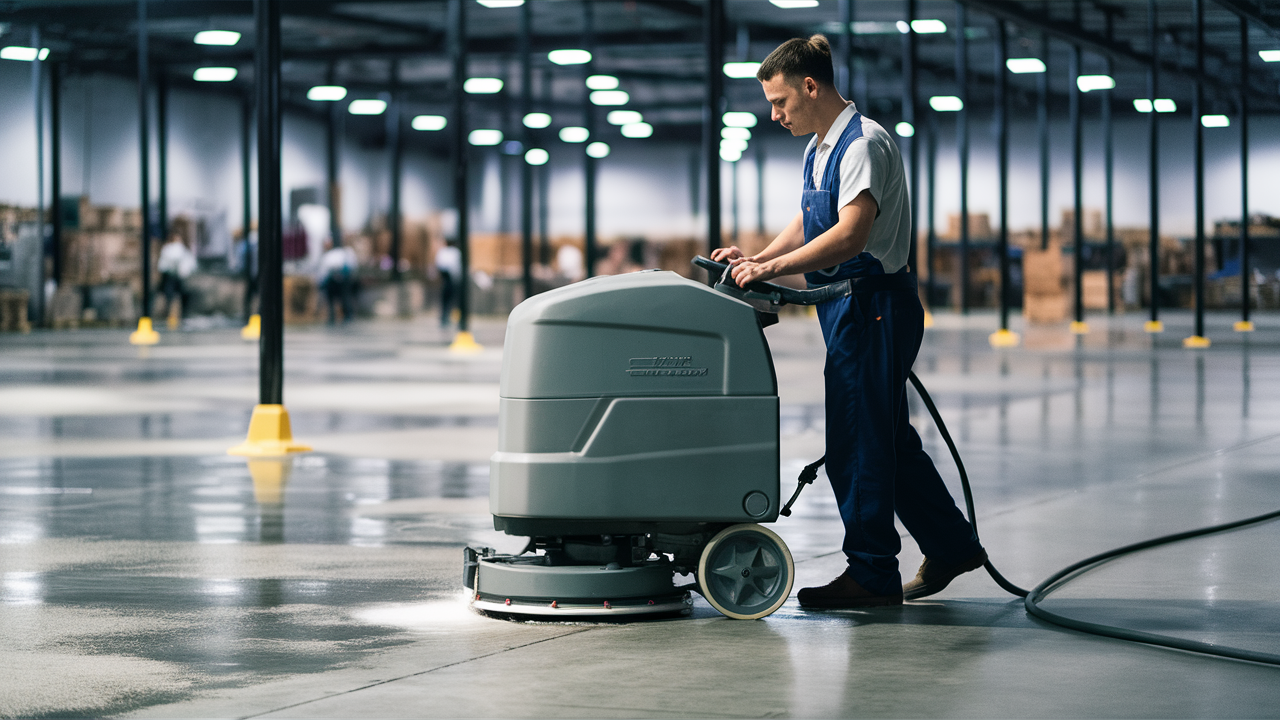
[253,0,284,405]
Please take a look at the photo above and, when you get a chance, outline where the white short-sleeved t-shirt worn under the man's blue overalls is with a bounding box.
[804,102,911,274]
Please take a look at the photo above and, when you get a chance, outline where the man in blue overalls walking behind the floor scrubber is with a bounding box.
[712,35,987,607]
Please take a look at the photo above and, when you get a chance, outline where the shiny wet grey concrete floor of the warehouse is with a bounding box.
[0,307,1280,717]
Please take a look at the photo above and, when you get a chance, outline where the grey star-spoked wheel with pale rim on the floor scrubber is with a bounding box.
[698,523,795,620]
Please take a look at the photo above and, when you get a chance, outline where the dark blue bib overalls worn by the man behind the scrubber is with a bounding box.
[801,113,980,596]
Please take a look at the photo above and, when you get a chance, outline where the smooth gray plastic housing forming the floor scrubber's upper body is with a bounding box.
[489,270,778,534]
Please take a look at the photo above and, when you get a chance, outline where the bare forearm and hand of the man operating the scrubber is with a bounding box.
[733,190,879,286]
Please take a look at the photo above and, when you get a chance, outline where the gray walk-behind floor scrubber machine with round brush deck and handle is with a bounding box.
[463,258,847,619]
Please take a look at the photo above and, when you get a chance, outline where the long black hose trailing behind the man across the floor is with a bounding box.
[908,372,1280,665]
